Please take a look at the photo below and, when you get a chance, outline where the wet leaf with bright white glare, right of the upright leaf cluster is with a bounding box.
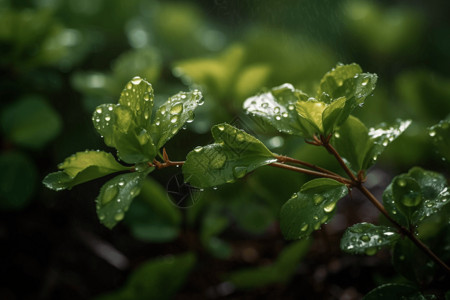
[363,120,411,169]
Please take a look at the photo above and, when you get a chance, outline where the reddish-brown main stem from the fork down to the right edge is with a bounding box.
[355,184,450,272]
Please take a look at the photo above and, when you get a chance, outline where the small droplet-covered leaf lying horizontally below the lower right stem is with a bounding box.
[341,223,400,255]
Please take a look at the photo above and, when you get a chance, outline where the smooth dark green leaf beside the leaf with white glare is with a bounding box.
[332,116,371,171]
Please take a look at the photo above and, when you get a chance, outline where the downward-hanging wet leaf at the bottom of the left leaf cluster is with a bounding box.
[95,169,153,229]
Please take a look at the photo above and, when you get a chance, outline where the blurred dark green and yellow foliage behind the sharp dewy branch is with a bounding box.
[0,0,450,299]
